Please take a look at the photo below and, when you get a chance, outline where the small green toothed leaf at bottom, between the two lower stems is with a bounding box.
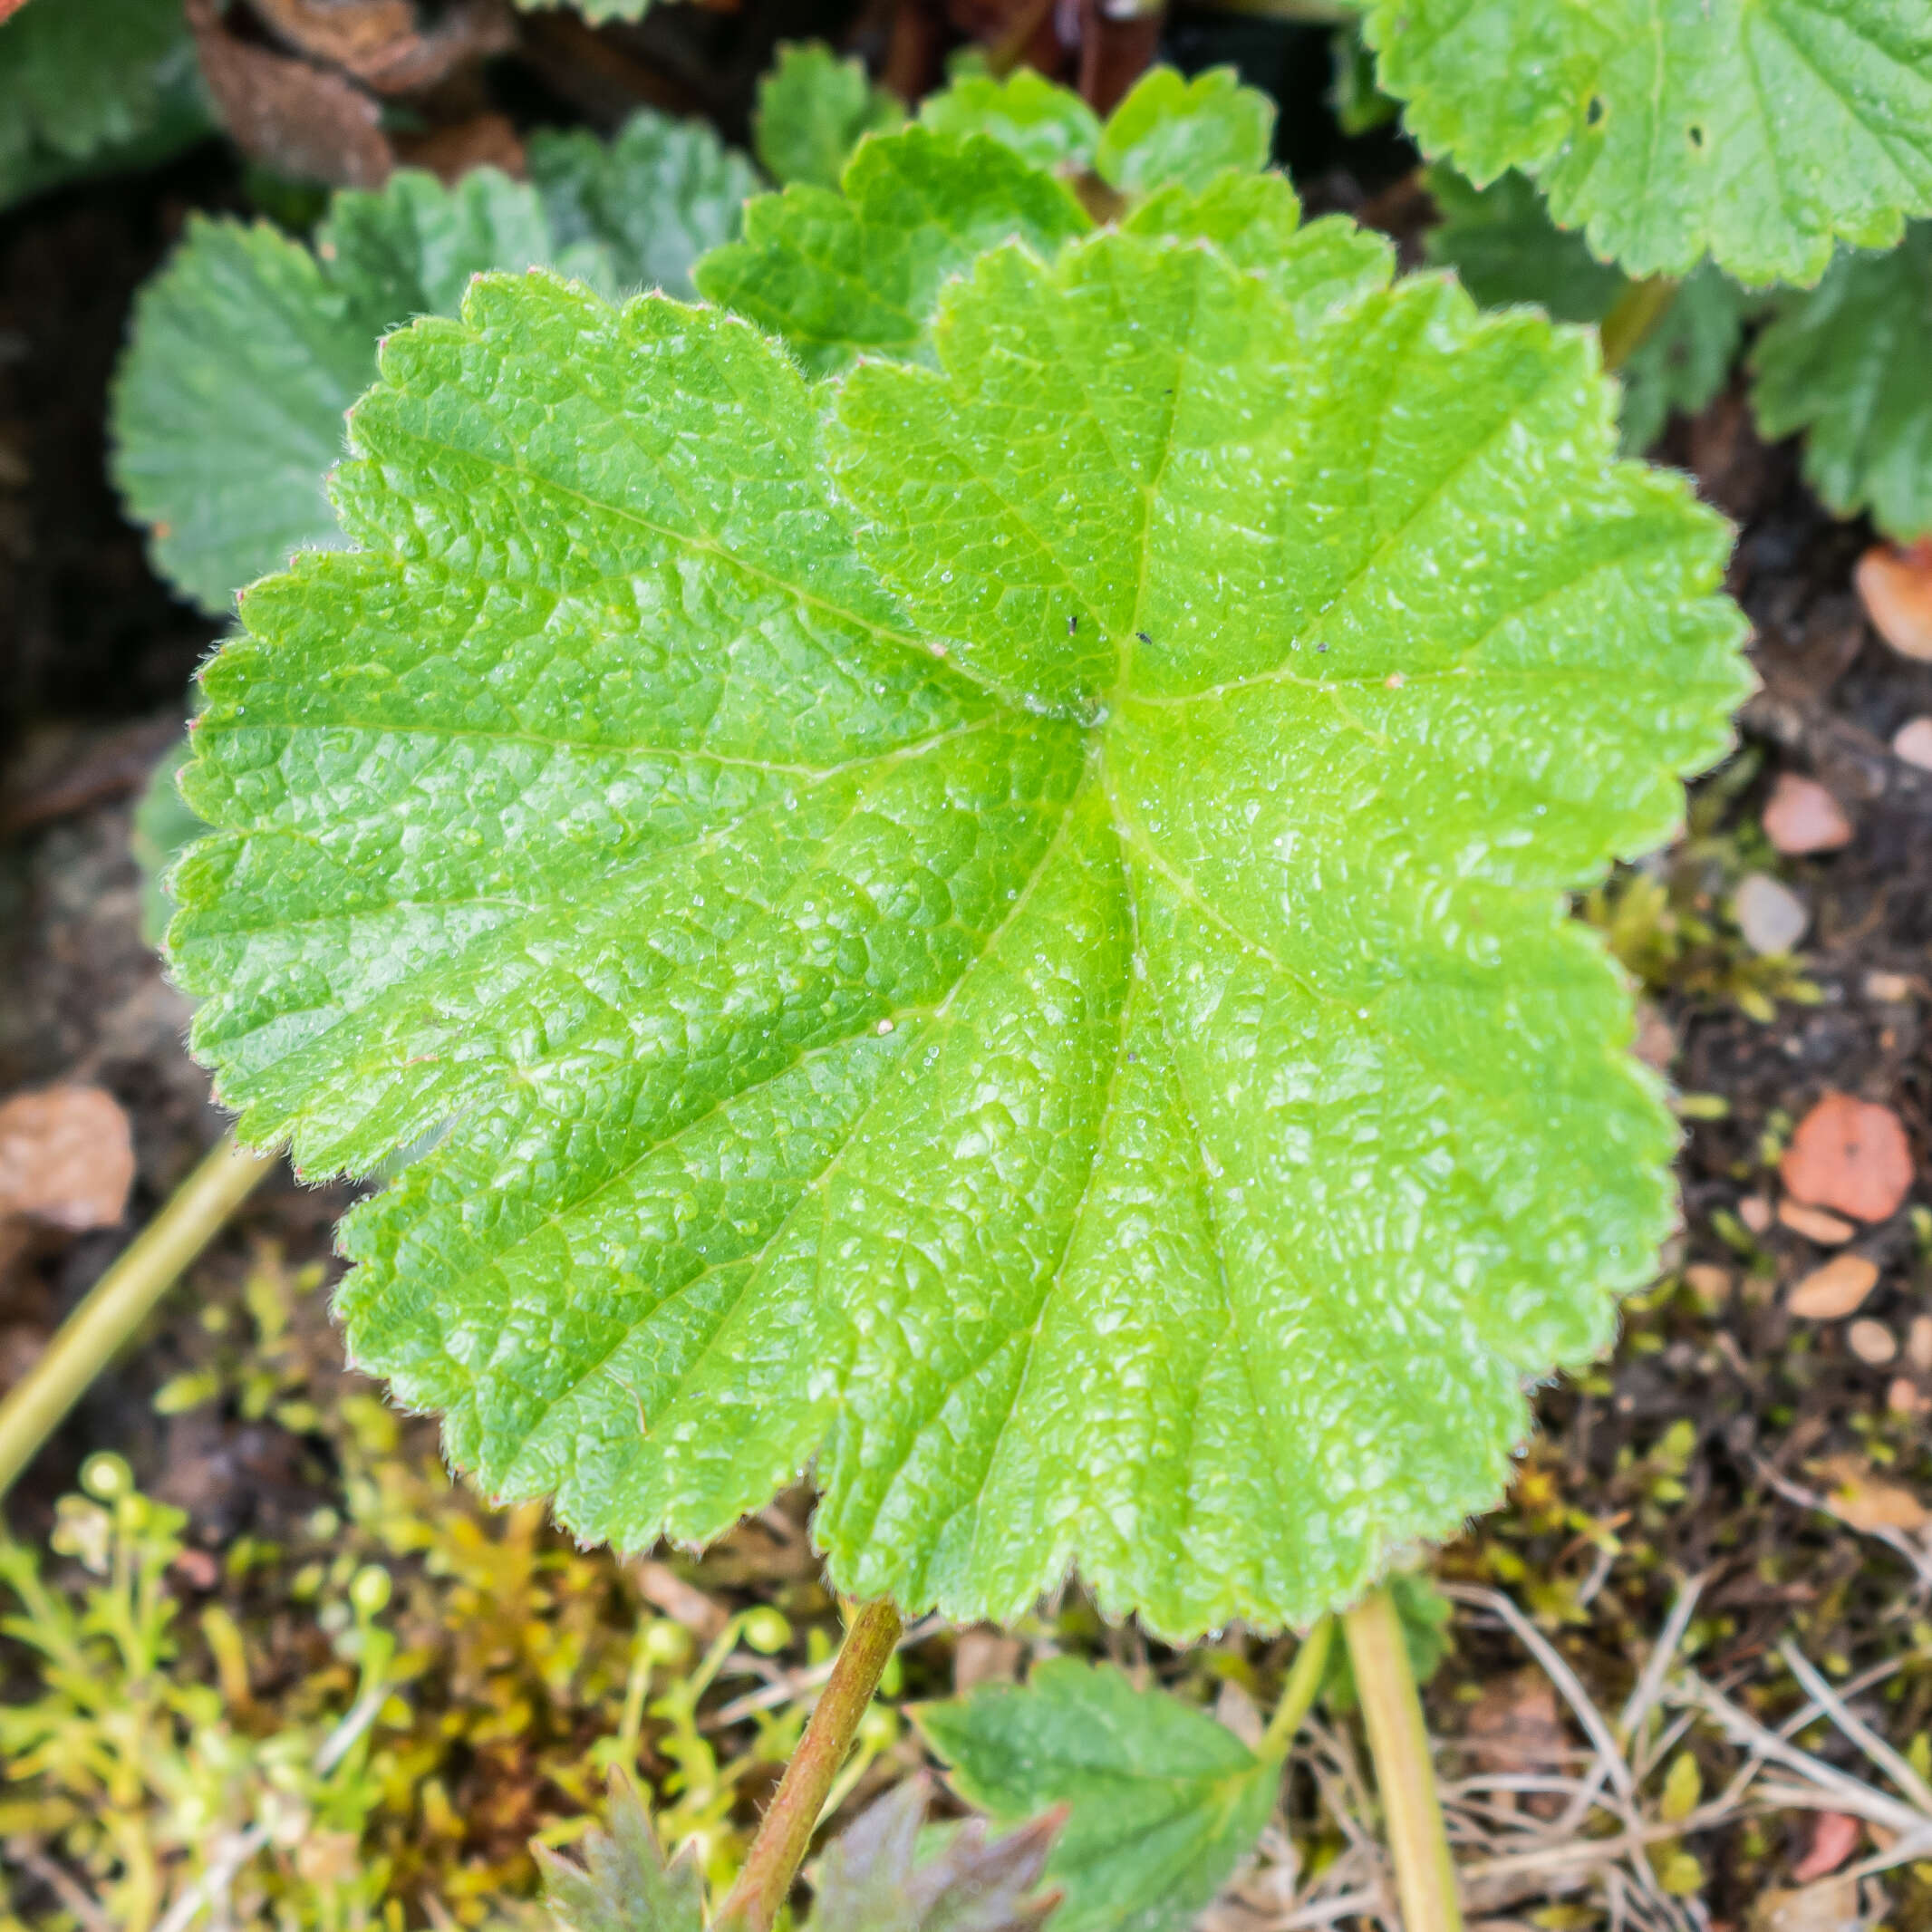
[913,1657,1281,1932]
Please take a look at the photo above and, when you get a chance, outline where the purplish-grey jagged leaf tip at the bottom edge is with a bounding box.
[807,1775,1060,1932]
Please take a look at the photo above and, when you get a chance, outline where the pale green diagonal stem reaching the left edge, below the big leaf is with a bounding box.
[0,1134,276,1497]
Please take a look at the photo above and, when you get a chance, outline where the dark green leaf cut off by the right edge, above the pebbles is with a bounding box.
[1751,222,1932,543]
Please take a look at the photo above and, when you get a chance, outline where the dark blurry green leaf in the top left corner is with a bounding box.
[0,0,213,207]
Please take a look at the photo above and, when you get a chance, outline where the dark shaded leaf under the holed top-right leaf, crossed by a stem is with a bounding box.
[1425,164,1754,452]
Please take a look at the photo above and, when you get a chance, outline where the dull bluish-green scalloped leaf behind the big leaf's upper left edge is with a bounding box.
[112,112,756,613]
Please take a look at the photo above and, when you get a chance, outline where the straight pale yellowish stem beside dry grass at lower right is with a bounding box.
[1343,1590,1463,1932]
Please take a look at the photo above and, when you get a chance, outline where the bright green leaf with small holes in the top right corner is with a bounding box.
[1366,0,1932,284]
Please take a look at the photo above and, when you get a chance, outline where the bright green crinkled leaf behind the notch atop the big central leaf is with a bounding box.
[696,126,1094,375]
